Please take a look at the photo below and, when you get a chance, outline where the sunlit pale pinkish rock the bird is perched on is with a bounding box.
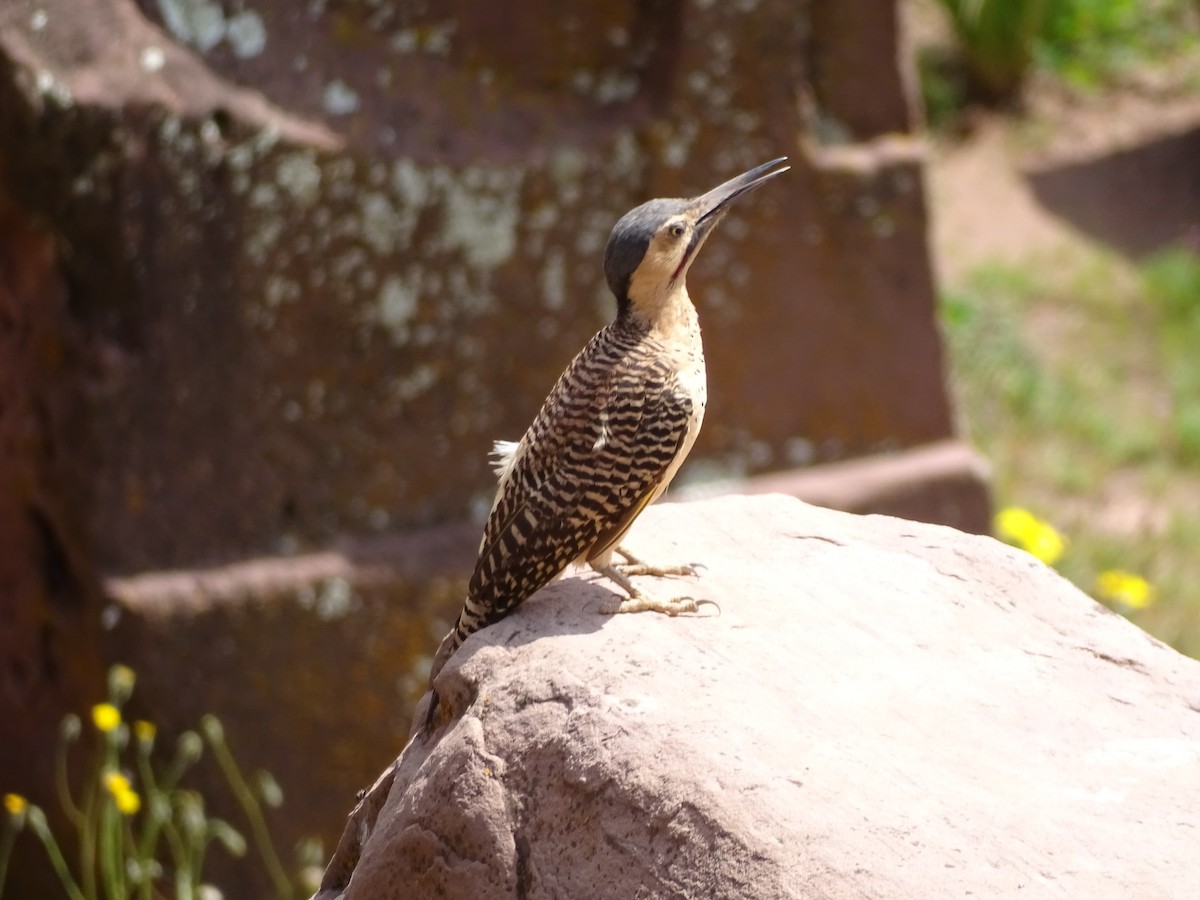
[317,497,1200,900]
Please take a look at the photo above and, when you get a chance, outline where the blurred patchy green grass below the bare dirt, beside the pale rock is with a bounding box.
[942,250,1200,658]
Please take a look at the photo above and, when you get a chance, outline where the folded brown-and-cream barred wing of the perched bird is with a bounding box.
[468,336,692,626]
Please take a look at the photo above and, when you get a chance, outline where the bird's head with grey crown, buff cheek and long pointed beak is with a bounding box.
[604,156,788,318]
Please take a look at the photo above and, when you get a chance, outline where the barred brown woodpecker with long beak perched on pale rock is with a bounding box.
[430,157,790,691]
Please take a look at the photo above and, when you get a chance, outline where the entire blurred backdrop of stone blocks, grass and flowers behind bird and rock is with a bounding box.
[0,0,1200,898]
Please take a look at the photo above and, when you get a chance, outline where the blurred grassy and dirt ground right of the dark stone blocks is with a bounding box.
[905,0,1200,656]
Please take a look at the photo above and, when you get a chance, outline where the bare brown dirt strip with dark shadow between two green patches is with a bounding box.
[928,108,1200,284]
